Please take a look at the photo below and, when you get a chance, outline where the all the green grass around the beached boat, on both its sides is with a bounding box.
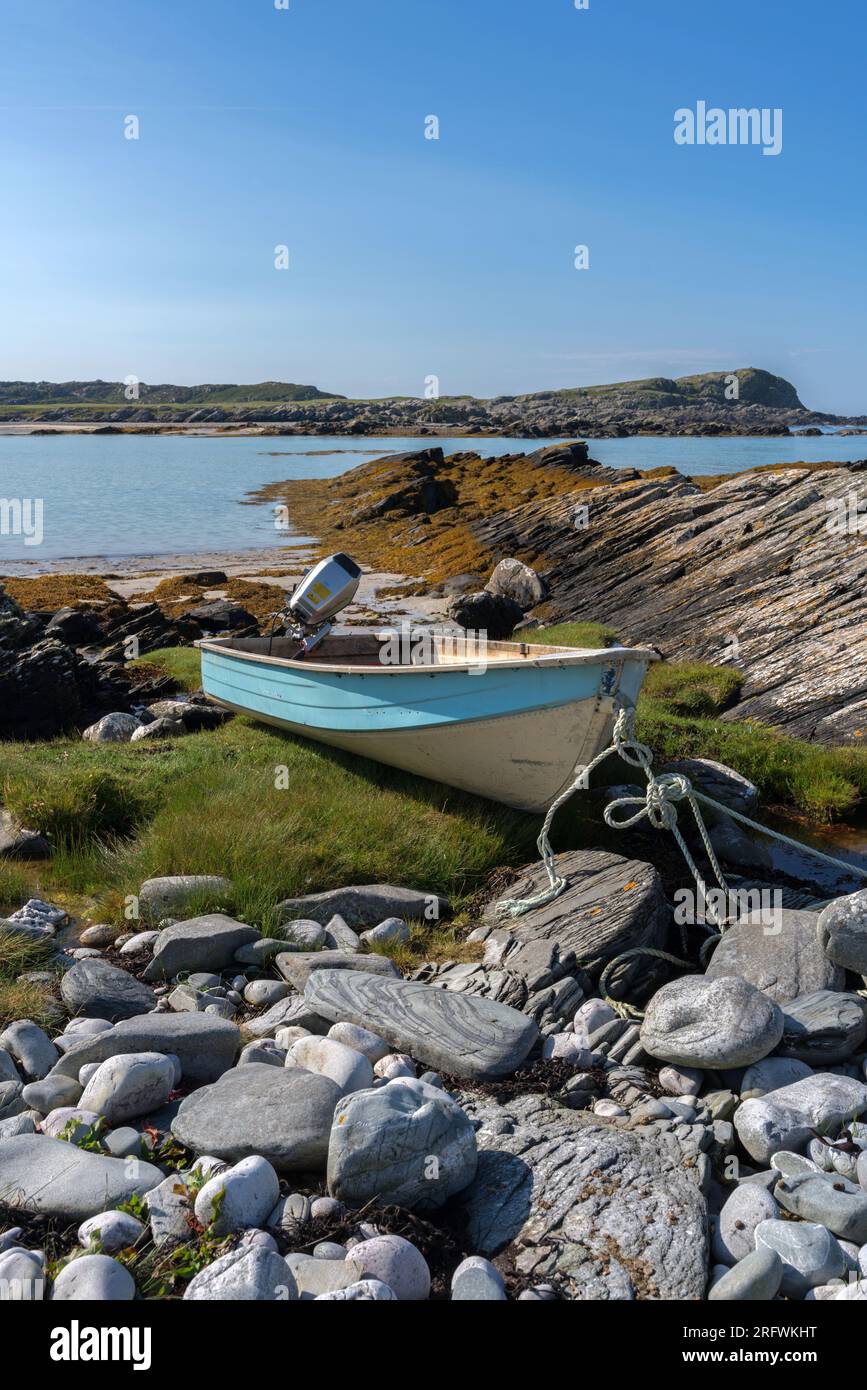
[0,636,867,973]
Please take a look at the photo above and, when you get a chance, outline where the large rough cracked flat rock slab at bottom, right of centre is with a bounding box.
[456,1095,707,1301]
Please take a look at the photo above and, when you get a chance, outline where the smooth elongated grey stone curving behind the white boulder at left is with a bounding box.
[51,1013,240,1086]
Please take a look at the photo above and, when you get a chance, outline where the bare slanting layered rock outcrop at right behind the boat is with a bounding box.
[474,460,867,744]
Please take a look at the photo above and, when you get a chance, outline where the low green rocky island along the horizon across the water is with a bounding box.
[0,367,867,438]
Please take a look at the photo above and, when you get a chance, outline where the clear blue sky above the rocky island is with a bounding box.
[0,0,867,413]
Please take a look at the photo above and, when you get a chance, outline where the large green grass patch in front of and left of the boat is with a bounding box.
[0,719,536,929]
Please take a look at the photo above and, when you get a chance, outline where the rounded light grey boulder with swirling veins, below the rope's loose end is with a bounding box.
[641,974,782,1070]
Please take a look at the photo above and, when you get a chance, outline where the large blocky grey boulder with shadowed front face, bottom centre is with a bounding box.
[328,1079,478,1209]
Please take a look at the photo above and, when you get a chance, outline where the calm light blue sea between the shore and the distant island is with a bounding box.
[0,434,867,573]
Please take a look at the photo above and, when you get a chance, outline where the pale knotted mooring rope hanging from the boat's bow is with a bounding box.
[495,702,867,1019]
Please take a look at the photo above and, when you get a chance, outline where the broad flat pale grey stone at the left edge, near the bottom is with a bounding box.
[0,1134,163,1222]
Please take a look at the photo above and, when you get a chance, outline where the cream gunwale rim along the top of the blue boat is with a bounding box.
[193,637,660,676]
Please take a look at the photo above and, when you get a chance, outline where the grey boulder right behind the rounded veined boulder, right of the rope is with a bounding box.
[706,908,846,1004]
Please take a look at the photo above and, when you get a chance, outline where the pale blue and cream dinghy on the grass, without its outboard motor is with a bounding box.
[196,628,657,812]
